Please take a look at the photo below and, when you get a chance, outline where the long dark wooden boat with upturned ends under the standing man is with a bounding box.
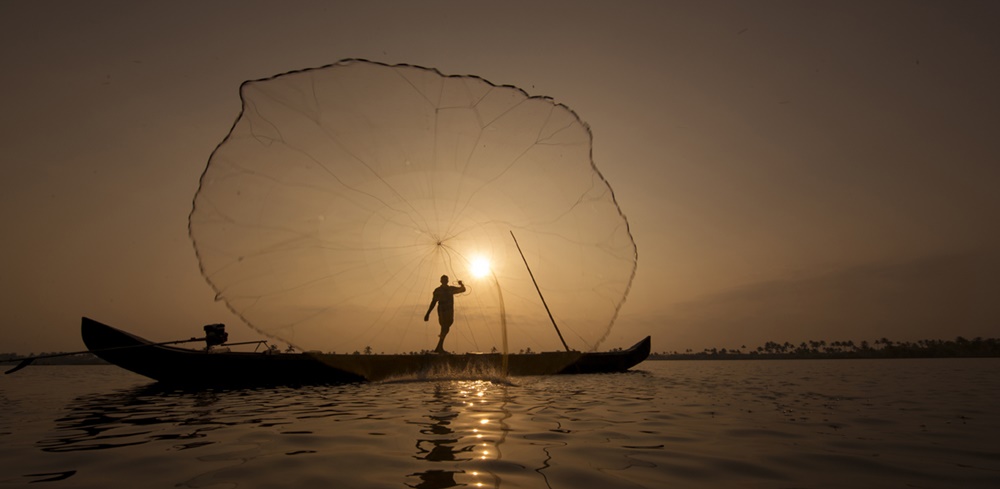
[81,317,650,386]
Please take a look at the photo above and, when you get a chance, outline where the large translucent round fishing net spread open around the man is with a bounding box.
[189,59,636,353]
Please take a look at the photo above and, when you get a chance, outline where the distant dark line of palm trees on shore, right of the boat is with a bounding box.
[649,336,1000,360]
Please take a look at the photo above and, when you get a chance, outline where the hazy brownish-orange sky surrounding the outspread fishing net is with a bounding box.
[0,1,1000,353]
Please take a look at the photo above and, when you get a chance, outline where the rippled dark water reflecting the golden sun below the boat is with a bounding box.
[0,359,1000,489]
